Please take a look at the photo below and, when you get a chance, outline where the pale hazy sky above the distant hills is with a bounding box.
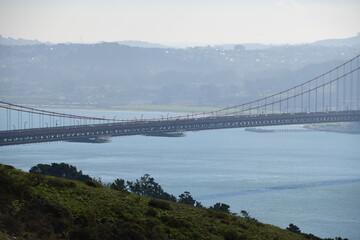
[0,0,360,45]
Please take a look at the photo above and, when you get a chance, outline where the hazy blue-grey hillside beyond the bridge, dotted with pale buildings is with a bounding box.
[0,43,360,107]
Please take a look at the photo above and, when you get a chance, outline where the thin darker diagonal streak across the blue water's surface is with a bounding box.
[195,178,360,200]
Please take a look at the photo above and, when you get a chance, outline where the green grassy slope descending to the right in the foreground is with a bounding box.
[0,165,319,240]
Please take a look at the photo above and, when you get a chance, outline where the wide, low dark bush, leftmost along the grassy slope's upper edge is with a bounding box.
[29,163,92,181]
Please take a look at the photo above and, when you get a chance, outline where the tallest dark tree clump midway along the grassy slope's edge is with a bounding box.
[127,174,176,202]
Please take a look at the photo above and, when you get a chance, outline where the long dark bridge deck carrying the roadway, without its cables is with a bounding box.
[0,110,360,146]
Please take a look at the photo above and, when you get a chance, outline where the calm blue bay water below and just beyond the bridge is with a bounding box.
[0,110,360,240]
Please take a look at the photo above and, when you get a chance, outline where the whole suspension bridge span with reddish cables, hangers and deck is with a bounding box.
[0,55,360,146]
